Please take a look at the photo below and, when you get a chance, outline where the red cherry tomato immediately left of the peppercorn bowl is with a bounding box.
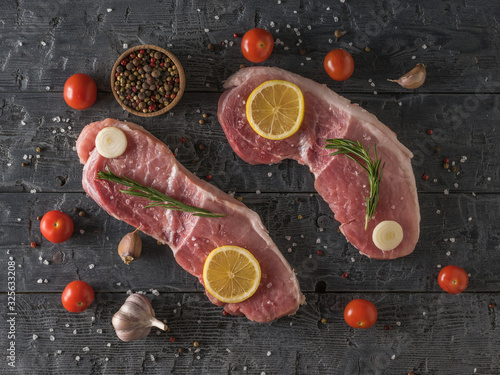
[64,73,97,109]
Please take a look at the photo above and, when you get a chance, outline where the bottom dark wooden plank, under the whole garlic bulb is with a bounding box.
[0,293,500,375]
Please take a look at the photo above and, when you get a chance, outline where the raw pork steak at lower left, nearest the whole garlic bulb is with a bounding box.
[76,119,304,322]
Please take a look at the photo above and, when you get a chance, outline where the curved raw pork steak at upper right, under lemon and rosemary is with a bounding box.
[218,67,420,259]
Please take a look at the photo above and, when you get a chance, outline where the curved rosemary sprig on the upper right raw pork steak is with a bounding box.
[325,138,385,230]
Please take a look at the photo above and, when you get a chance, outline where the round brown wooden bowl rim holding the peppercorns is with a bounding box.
[111,44,186,117]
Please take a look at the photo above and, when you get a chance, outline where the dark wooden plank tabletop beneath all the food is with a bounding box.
[0,0,500,375]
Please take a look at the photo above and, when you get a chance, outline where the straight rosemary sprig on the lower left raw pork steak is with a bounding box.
[97,166,226,217]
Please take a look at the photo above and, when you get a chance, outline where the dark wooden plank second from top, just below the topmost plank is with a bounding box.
[0,93,500,193]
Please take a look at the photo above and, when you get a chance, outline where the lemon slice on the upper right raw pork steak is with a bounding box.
[246,80,304,140]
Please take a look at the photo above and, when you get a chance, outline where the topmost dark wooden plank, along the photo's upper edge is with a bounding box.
[0,0,500,93]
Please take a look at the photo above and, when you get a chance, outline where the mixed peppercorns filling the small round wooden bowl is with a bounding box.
[114,48,180,113]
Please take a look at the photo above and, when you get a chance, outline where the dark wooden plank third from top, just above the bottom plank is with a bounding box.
[0,193,500,293]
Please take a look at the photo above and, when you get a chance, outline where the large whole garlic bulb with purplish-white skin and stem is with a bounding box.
[111,293,168,342]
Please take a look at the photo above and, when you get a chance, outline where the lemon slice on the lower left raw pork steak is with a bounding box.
[203,246,261,303]
